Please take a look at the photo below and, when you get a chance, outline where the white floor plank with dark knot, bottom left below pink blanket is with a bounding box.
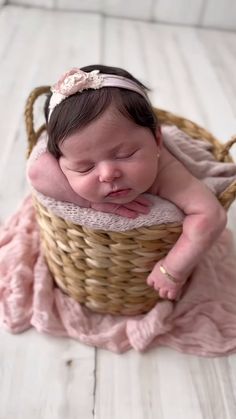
[0,330,95,419]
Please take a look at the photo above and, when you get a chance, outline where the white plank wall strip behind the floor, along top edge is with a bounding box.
[5,0,236,31]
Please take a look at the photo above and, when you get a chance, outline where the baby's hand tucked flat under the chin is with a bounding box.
[91,196,152,218]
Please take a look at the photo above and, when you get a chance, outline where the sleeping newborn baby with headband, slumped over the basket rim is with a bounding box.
[28,65,227,300]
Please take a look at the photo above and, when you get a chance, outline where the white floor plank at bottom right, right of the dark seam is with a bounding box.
[95,348,236,419]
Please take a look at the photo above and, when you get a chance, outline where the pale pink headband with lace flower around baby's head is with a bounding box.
[48,68,148,119]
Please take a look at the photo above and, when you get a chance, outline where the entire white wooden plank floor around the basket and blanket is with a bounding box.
[0,6,236,419]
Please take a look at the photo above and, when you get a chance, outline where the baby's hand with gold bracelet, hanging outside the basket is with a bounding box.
[147,259,187,300]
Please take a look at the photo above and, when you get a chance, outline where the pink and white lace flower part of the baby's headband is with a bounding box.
[49,67,103,116]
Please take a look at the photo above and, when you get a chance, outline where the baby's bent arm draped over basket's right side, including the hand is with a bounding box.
[148,151,227,299]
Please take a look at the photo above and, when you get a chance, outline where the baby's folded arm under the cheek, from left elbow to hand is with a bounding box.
[27,151,151,218]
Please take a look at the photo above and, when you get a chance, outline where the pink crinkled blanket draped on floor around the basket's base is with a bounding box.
[0,197,236,356]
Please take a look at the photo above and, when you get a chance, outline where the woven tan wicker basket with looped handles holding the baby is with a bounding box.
[25,86,236,315]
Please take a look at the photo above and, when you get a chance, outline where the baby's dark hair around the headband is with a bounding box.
[44,65,158,159]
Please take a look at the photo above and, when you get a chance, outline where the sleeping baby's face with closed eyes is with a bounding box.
[59,107,160,204]
